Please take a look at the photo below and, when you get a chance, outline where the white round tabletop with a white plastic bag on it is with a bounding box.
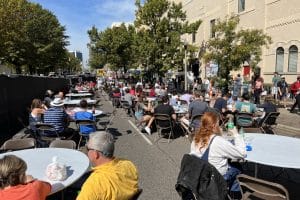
[0,148,90,194]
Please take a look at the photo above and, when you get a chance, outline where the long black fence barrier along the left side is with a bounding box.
[0,75,69,145]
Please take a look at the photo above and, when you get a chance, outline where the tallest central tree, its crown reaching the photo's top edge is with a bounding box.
[134,0,201,74]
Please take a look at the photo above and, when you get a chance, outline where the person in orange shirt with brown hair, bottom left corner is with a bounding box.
[0,155,51,200]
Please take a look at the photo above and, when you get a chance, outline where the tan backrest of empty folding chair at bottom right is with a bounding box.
[237,174,289,200]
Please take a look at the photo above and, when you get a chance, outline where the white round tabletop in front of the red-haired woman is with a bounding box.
[245,133,300,169]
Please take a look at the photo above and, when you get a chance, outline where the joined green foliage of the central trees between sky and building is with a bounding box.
[88,0,201,74]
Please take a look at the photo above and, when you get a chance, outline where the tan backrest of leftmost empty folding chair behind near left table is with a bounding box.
[2,138,36,151]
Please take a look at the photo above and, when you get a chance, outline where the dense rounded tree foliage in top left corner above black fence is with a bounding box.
[0,0,68,73]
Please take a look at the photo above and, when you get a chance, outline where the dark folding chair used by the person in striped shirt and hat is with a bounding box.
[35,123,59,147]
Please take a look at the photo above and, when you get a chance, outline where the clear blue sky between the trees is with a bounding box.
[30,0,136,65]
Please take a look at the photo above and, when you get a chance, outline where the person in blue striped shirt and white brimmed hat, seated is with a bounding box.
[44,98,73,137]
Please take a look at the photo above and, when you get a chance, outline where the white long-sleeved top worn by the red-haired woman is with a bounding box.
[191,135,246,175]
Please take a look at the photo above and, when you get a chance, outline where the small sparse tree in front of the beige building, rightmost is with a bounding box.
[204,16,271,88]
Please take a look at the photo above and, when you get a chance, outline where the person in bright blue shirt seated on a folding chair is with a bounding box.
[74,99,96,134]
